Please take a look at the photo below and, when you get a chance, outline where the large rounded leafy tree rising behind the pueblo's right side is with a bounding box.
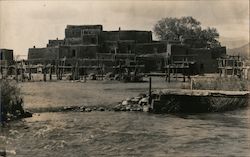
[154,16,220,47]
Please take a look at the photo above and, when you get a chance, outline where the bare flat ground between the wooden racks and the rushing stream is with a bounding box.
[19,77,189,109]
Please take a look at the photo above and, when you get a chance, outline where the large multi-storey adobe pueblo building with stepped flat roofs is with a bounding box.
[28,25,226,74]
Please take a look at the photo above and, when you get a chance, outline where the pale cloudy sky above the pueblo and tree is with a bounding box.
[0,0,249,55]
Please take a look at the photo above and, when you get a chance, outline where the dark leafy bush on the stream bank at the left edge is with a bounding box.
[0,80,25,121]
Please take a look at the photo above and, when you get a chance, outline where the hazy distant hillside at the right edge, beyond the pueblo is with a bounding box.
[227,43,250,58]
